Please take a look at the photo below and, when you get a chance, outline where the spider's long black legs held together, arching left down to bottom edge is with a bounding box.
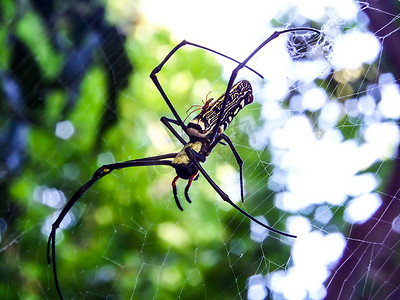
[47,153,177,299]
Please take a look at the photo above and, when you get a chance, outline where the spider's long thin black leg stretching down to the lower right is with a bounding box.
[186,149,297,238]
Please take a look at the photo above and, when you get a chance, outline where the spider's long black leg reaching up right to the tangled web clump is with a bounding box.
[212,27,320,140]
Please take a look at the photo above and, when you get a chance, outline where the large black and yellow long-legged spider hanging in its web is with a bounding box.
[47,27,320,299]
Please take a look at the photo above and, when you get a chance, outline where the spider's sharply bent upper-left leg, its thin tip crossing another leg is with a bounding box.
[150,40,264,132]
